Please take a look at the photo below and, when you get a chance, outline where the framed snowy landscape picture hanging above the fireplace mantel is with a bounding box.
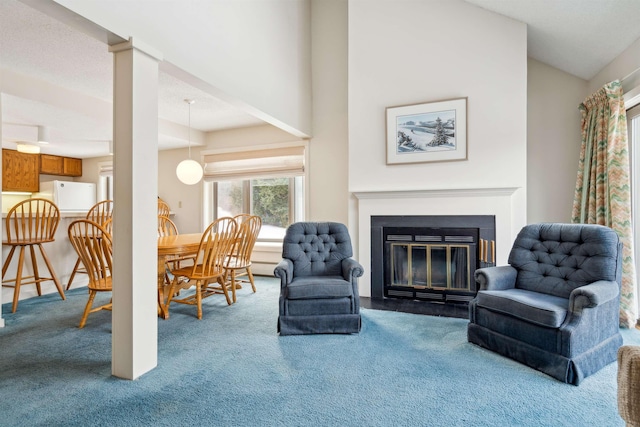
[387,98,467,165]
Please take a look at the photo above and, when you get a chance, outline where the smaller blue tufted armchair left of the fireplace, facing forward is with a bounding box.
[274,222,364,335]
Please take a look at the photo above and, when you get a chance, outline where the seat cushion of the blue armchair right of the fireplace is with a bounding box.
[476,289,569,328]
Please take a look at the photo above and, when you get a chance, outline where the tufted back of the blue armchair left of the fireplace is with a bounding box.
[282,222,353,277]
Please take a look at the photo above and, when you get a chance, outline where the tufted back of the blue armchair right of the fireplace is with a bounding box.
[509,224,622,298]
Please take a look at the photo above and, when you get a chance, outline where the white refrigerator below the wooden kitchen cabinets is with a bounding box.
[39,180,96,212]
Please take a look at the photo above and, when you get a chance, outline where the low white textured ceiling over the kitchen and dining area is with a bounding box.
[0,0,264,157]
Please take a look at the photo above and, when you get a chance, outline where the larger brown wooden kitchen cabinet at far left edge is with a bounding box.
[2,148,40,193]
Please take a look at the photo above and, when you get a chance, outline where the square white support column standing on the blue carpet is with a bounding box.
[109,39,162,380]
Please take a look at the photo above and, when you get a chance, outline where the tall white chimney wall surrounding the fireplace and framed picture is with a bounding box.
[348,0,527,284]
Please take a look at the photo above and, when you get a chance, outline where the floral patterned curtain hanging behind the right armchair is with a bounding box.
[571,80,638,328]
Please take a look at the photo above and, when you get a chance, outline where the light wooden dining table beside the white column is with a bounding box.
[158,233,202,319]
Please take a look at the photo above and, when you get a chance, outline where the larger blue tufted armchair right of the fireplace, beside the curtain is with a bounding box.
[467,224,622,385]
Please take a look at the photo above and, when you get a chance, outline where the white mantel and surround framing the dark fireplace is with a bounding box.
[352,187,526,297]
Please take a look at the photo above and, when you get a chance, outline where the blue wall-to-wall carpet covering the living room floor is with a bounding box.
[0,277,640,427]
